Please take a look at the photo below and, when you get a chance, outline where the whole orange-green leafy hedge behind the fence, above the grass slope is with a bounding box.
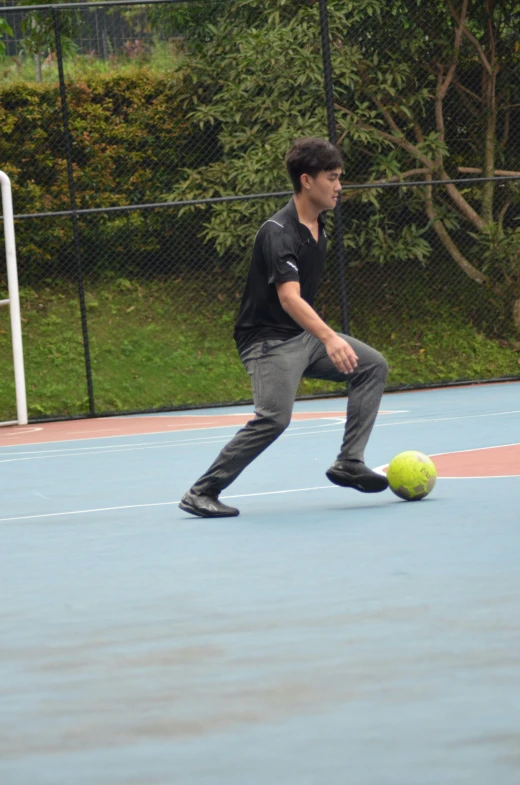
[0,68,218,285]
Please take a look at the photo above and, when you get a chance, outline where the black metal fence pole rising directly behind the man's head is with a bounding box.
[320,0,350,335]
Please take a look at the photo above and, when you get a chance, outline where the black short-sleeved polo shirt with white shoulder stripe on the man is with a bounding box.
[234,199,327,352]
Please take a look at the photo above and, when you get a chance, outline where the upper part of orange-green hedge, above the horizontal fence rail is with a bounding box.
[0,68,204,213]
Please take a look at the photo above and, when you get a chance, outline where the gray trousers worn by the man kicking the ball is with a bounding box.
[192,332,388,495]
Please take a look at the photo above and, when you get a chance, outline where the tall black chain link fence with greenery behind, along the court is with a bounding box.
[0,0,520,419]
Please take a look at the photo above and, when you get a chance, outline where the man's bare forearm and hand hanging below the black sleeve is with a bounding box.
[276,281,358,373]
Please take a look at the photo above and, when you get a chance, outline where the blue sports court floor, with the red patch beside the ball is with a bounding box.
[0,383,520,785]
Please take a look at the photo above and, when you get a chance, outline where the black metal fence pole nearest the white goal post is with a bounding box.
[52,8,96,417]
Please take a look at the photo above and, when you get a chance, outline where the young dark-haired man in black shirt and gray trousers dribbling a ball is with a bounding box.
[179,137,388,518]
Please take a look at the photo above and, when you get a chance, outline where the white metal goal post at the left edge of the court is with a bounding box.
[0,171,28,425]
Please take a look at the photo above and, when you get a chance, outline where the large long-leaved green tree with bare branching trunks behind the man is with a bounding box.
[170,0,520,333]
